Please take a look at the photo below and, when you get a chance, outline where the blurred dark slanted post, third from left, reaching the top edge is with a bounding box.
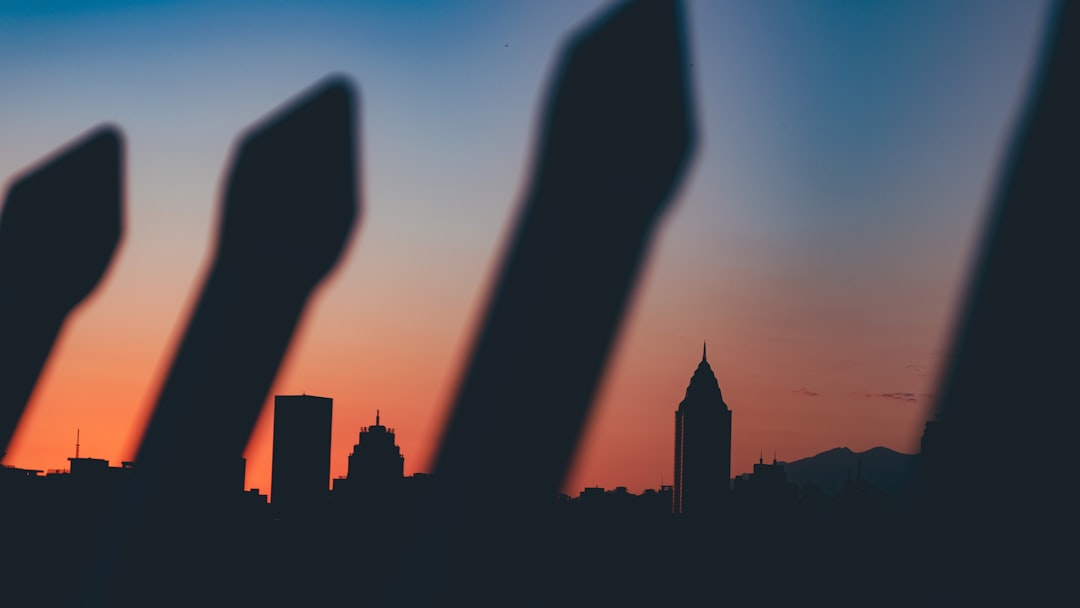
[387,0,696,606]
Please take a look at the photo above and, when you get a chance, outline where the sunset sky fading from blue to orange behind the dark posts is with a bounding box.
[0,0,1049,495]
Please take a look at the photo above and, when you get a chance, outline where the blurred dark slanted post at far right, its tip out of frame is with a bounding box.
[915,2,1080,606]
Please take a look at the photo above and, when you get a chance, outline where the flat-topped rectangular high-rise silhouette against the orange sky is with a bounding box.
[270,395,334,516]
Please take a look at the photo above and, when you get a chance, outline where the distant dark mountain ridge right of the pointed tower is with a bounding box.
[783,446,918,495]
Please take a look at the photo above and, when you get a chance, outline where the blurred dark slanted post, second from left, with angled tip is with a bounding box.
[83,78,357,606]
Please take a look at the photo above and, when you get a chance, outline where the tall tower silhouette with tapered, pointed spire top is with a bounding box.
[672,346,731,516]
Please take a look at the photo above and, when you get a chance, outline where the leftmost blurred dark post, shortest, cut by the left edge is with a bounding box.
[0,126,123,458]
